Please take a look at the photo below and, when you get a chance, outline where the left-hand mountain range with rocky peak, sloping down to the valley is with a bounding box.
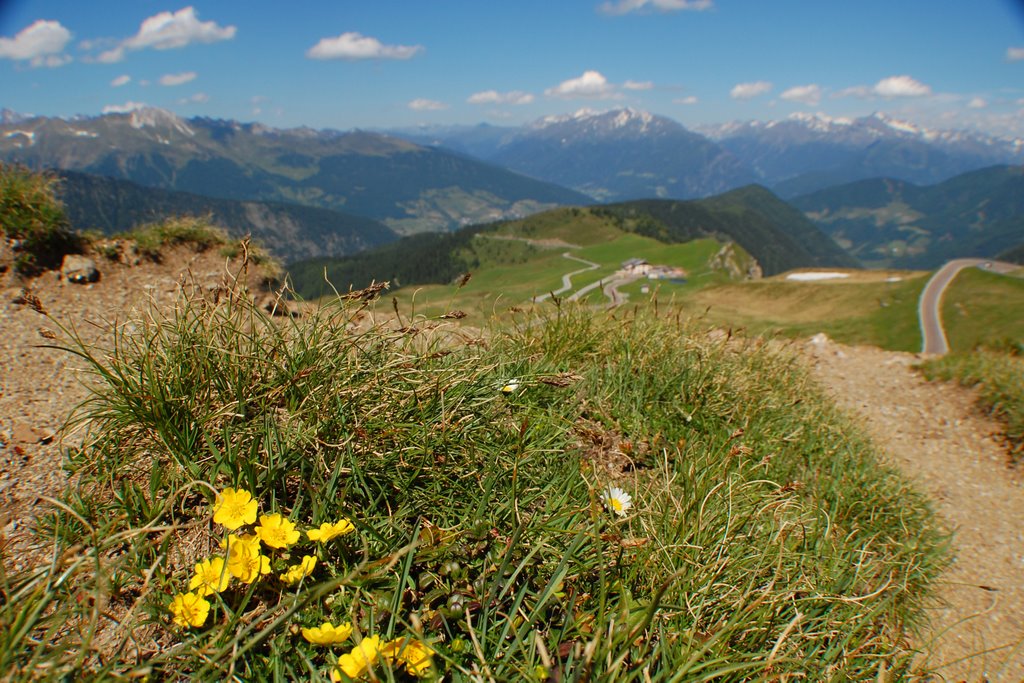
[0,109,590,232]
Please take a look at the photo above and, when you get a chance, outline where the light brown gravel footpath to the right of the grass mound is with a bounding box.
[807,336,1024,683]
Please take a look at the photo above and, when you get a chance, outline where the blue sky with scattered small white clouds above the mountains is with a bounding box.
[0,0,1024,136]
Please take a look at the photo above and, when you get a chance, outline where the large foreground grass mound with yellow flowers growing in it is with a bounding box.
[0,280,941,681]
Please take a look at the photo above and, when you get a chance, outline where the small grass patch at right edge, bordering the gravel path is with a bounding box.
[921,340,1024,463]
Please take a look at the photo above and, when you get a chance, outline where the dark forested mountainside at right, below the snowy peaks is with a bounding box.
[790,166,1024,268]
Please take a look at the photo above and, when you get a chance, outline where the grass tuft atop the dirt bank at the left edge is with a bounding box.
[0,163,82,275]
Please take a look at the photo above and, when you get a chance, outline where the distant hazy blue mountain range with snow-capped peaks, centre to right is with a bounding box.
[389,109,1024,201]
